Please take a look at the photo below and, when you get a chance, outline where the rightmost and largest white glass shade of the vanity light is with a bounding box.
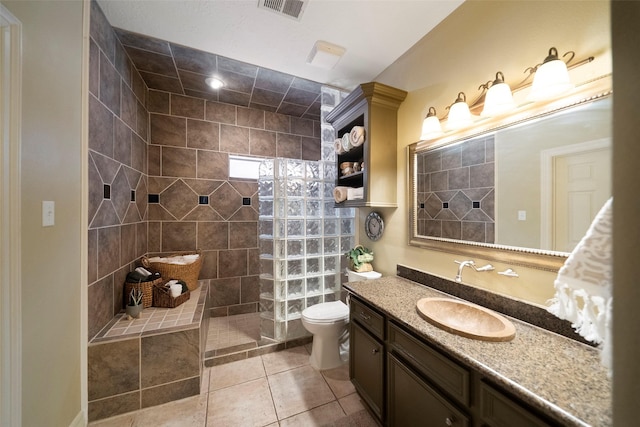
[527,48,574,101]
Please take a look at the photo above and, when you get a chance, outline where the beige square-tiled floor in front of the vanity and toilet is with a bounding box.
[89,345,377,427]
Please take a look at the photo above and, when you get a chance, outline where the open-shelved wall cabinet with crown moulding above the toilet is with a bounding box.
[326,82,407,207]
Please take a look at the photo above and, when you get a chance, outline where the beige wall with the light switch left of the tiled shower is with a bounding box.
[3,1,86,426]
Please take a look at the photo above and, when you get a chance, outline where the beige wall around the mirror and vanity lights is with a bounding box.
[370,1,611,304]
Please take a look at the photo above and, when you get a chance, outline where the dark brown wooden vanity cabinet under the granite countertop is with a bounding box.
[349,294,559,427]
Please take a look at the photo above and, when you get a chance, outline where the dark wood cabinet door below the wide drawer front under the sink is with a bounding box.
[387,356,470,427]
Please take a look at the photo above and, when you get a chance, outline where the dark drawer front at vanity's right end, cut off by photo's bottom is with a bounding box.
[480,382,554,427]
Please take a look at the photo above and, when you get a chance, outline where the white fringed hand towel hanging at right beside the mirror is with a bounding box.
[547,199,613,368]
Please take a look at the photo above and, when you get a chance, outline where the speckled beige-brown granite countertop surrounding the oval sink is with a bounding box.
[344,277,613,426]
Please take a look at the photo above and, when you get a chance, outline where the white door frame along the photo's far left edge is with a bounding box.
[0,4,22,426]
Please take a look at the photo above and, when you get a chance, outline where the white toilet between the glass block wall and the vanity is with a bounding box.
[302,270,382,370]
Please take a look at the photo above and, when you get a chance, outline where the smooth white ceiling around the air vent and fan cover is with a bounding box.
[97,0,463,90]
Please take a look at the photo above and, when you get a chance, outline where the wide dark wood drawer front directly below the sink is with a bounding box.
[389,322,469,406]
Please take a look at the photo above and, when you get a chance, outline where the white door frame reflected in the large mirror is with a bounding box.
[540,137,612,250]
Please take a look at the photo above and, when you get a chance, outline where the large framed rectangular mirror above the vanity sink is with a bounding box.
[408,76,612,271]
